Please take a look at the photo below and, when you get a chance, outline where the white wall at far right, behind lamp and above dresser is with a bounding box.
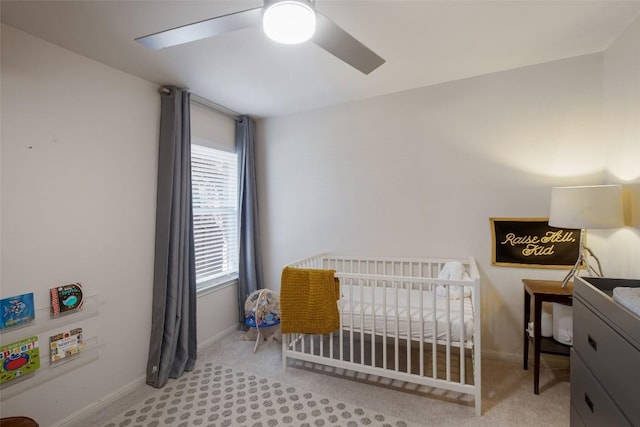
[604,17,640,278]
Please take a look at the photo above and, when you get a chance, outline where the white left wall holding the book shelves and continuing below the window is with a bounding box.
[0,25,237,426]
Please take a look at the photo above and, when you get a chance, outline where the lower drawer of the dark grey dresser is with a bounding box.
[571,349,631,427]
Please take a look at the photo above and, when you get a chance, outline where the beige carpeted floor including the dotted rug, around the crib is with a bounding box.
[69,332,569,427]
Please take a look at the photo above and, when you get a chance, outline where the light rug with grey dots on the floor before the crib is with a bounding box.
[104,362,409,427]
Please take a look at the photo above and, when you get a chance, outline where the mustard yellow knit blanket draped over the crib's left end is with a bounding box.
[280,267,340,334]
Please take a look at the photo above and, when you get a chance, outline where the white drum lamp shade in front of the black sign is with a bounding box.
[549,185,624,229]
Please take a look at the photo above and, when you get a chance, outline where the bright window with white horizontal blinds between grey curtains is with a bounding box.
[191,142,238,289]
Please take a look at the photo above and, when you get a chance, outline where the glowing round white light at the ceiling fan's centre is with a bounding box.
[262,0,316,44]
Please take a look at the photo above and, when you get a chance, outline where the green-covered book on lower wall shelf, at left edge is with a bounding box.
[0,336,40,384]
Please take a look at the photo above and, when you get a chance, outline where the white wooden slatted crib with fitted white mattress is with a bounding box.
[282,254,482,415]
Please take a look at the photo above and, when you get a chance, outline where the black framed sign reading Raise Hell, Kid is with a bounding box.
[490,218,580,269]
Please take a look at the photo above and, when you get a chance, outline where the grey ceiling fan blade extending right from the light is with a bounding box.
[311,10,385,74]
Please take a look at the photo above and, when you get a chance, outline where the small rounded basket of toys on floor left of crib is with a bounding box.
[243,289,280,353]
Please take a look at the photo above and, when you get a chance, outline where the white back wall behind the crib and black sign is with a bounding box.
[258,54,607,357]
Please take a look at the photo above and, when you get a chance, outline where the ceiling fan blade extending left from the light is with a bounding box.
[136,7,262,49]
